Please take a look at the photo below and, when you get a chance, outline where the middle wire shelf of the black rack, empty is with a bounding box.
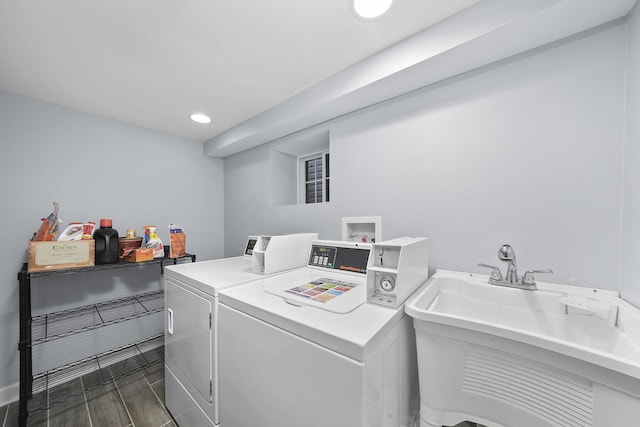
[31,291,164,345]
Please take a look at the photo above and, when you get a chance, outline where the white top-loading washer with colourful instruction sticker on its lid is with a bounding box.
[218,241,419,427]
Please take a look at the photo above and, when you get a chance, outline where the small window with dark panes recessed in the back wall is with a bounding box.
[300,151,330,203]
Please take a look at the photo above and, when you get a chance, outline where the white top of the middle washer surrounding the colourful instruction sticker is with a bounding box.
[219,267,404,362]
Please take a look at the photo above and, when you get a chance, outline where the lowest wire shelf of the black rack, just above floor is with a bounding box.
[28,334,164,414]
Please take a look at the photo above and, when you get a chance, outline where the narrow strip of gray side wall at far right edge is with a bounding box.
[620,4,640,307]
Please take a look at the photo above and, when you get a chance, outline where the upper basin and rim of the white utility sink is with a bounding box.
[416,273,640,364]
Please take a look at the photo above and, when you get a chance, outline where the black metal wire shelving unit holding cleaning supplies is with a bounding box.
[18,254,196,427]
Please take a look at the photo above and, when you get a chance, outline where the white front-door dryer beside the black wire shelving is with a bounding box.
[164,233,317,427]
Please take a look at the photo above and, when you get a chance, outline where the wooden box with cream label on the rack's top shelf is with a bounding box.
[27,240,96,273]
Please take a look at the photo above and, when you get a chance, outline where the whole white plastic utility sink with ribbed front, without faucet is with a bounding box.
[405,270,640,427]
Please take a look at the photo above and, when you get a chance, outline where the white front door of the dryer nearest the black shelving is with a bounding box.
[164,277,213,402]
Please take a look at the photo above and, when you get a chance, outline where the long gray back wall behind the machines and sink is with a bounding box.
[225,22,626,289]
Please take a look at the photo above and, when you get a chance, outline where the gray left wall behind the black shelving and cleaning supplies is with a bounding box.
[0,92,224,398]
